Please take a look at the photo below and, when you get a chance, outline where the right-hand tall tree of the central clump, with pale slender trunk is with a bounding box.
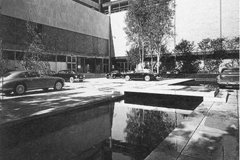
[144,0,174,73]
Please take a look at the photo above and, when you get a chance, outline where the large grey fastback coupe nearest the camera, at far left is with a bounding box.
[0,71,64,95]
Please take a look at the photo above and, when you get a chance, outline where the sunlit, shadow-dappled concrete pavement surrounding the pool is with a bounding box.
[0,78,239,160]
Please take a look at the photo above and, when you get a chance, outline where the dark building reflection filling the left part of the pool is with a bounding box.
[0,103,113,160]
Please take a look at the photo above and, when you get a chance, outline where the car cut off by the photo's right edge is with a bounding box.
[217,68,239,89]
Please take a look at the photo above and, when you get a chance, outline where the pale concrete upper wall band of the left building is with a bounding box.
[1,0,109,39]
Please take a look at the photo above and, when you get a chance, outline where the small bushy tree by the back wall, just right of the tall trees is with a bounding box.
[175,40,201,73]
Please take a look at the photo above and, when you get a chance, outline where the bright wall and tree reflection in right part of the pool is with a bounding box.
[111,101,191,160]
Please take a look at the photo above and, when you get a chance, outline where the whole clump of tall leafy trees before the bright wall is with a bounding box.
[125,0,174,73]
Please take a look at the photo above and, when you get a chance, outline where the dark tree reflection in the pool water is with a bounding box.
[124,108,175,160]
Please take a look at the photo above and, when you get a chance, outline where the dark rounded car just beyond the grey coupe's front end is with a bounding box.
[52,70,85,83]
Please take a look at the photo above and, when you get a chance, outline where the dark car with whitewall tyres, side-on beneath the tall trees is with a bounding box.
[125,71,159,81]
